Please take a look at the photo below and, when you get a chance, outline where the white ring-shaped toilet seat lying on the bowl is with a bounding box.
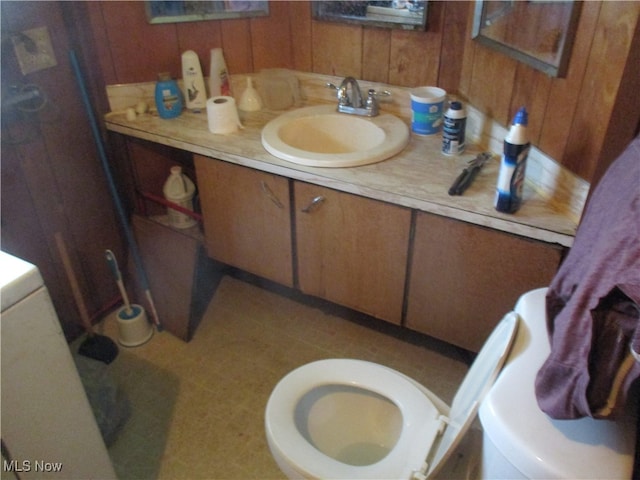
[265,359,444,479]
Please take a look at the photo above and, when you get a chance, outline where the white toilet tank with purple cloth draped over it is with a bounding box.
[480,289,637,479]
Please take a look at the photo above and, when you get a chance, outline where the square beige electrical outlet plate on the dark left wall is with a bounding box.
[11,27,58,75]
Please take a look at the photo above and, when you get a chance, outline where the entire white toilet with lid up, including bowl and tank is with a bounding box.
[265,289,635,479]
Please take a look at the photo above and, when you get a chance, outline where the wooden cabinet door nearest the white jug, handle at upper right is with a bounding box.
[195,155,293,286]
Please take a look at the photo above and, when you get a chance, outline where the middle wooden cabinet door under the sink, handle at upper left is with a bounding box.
[294,182,411,324]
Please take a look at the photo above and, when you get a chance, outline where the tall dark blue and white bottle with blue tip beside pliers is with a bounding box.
[494,107,531,213]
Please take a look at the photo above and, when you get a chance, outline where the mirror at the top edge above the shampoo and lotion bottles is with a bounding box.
[145,0,269,23]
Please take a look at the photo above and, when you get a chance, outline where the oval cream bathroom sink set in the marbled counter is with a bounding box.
[262,105,409,168]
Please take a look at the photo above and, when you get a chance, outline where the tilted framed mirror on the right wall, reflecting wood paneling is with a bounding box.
[472,0,580,77]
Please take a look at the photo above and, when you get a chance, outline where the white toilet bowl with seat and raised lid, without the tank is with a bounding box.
[265,312,518,479]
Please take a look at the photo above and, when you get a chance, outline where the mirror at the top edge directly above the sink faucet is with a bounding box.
[312,0,427,30]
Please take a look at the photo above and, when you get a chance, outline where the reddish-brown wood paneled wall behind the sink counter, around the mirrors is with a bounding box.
[88,1,640,185]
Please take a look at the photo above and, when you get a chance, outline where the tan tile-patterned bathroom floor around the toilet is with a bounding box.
[100,276,468,479]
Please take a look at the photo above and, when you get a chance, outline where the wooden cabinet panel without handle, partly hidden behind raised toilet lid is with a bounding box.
[406,212,562,351]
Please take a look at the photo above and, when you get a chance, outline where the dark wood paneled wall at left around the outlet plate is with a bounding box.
[0,1,125,339]
